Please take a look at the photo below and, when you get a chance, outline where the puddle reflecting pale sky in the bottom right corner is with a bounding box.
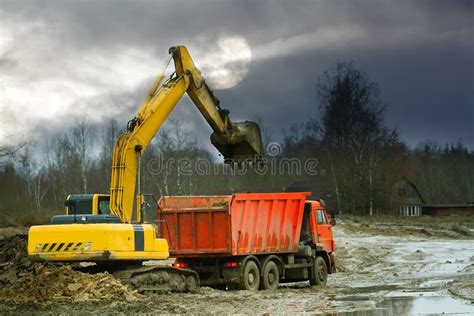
[338,296,474,316]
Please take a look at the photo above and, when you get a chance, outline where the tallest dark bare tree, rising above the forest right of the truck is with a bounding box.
[317,63,398,215]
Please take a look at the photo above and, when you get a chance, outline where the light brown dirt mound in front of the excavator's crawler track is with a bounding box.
[0,266,142,304]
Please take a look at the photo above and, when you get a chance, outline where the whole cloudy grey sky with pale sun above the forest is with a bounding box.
[0,0,474,154]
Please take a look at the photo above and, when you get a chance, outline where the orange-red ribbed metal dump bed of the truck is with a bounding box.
[158,192,310,257]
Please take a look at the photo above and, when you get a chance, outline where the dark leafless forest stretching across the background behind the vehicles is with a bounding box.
[0,63,474,214]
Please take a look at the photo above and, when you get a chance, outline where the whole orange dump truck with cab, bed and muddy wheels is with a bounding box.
[158,192,335,290]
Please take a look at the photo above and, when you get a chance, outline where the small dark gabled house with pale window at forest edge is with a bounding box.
[395,178,425,216]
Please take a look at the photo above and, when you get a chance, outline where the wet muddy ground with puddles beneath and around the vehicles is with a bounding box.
[0,217,474,315]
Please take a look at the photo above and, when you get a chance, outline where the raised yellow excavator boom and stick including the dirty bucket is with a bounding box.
[110,46,263,223]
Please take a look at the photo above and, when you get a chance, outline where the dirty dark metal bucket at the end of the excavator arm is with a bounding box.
[211,121,264,164]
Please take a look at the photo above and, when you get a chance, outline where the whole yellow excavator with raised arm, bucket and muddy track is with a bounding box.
[28,46,263,292]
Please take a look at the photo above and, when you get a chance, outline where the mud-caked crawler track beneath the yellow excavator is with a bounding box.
[112,266,200,293]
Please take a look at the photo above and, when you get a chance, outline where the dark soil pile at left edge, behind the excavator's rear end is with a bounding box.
[0,235,36,288]
